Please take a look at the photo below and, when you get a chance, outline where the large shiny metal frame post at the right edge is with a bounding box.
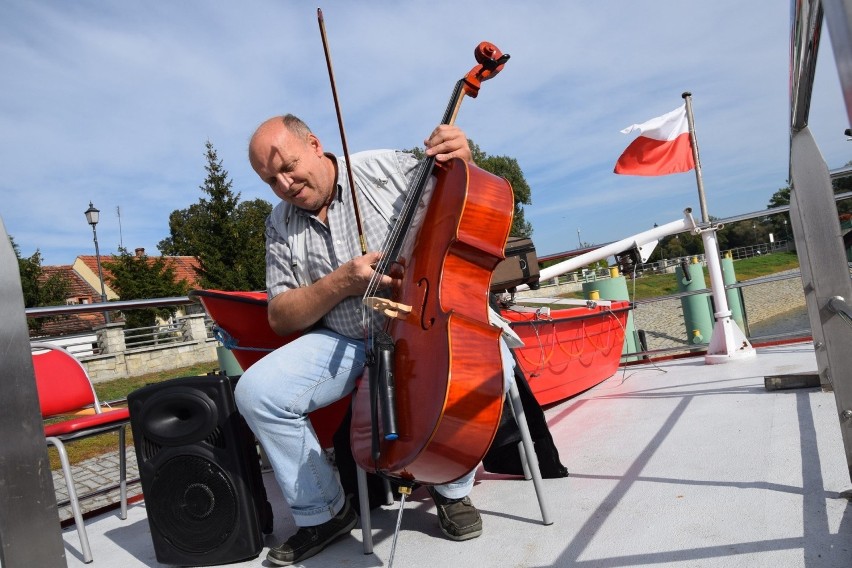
[790,0,852,484]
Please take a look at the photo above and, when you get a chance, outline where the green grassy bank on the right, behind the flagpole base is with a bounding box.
[563,252,799,300]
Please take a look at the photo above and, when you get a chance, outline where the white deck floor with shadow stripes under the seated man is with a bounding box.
[64,343,852,568]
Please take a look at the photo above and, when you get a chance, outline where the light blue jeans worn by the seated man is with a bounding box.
[235,329,514,526]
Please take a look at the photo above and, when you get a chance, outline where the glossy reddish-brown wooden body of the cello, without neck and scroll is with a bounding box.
[351,159,514,484]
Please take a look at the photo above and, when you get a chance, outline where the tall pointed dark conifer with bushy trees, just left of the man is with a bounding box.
[157,140,272,290]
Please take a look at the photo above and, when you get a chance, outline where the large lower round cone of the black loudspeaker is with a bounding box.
[145,455,239,554]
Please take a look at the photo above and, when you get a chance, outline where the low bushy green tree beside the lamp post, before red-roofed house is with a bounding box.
[104,248,189,329]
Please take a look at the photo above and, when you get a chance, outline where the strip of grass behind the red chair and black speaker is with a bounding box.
[48,362,219,469]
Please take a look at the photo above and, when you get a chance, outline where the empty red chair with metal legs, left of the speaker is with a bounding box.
[31,343,130,563]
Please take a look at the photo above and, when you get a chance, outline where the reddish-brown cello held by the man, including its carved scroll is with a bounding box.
[350,42,514,484]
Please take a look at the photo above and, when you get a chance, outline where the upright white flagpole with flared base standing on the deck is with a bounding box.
[682,91,756,365]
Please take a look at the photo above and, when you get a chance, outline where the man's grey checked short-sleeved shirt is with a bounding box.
[266,150,419,338]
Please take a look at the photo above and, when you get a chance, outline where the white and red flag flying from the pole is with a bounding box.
[613,103,695,176]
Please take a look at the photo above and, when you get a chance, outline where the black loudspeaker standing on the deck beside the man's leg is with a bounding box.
[127,375,272,566]
